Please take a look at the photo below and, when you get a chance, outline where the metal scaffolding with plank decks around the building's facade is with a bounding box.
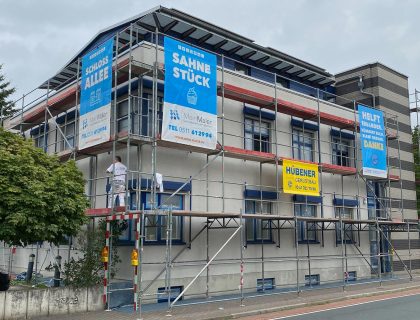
[4,23,418,312]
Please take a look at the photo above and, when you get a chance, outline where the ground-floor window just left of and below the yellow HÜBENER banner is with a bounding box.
[245,200,272,243]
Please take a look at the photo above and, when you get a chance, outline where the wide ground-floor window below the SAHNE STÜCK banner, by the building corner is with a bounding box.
[142,192,184,243]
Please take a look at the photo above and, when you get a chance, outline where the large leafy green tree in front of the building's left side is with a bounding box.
[0,127,88,246]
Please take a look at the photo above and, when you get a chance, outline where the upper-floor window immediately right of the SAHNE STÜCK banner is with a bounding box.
[245,118,270,152]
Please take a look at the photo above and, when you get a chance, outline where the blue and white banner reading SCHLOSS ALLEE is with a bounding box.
[79,39,114,150]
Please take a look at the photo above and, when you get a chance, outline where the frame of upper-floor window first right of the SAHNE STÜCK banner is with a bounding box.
[244,115,271,153]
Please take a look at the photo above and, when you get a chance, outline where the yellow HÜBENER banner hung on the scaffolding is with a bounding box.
[283,160,319,196]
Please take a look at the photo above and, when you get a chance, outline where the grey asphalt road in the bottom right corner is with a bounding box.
[267,294,420,320]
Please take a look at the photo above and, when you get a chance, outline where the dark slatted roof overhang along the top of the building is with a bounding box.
[39,6,335,89]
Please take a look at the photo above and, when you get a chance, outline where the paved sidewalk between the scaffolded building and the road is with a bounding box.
[38,279,420,320]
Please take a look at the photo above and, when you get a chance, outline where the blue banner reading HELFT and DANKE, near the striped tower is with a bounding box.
[358,104,388,178]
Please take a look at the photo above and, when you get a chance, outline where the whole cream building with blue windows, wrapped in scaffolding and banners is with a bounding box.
[1,7,420,307]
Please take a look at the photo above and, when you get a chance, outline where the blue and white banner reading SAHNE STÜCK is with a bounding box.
[162,37,217,149]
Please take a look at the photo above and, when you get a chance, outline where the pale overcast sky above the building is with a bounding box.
[0,0,420,121]
